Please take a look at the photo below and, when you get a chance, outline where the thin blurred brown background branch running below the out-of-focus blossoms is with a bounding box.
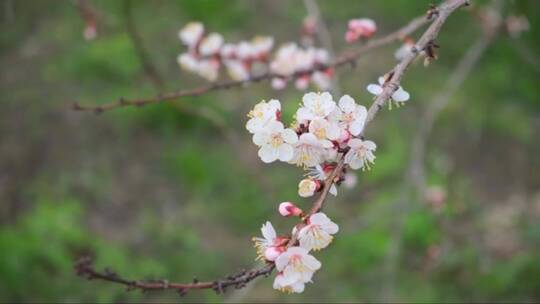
[73,9,429,113]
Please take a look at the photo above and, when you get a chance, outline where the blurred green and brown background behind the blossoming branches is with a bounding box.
[0,0,540,302]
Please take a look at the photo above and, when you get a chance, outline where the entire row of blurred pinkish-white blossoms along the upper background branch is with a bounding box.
[177,22,333,90]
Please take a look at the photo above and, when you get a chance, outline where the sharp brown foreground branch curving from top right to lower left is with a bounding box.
[75,0,468,295]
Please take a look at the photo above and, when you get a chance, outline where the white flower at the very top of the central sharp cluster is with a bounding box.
[296,92,336,122]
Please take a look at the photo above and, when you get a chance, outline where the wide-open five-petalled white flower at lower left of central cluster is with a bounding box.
[253,121,298,163]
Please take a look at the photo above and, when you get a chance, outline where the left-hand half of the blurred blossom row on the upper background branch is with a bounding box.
[177,22,274,81]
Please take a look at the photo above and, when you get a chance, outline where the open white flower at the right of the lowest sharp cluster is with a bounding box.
[298,212,339,250]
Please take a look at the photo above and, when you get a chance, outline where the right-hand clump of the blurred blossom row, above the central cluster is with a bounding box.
[270,42,334,90]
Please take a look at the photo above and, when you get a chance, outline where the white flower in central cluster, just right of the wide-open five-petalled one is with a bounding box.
[290,133,326,167]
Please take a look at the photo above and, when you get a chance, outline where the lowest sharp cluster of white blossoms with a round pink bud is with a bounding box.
[253,202,339,293]
